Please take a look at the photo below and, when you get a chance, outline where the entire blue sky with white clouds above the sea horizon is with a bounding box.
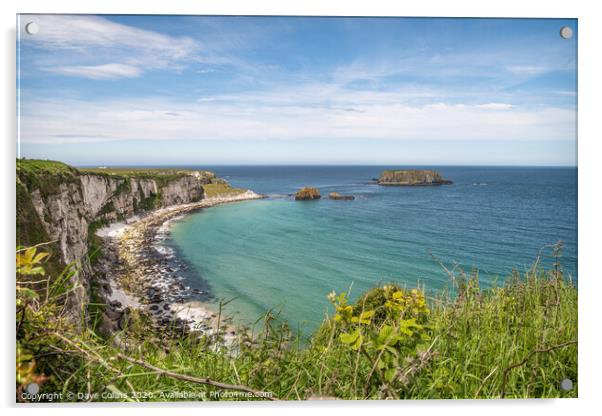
[17,15,577,166]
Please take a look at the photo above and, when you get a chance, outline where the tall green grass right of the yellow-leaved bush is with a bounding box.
[410,268,577,398]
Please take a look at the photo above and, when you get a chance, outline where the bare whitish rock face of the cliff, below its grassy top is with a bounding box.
[21,172,216,308]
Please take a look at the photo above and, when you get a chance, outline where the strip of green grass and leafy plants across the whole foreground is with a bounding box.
[16,244,578,401]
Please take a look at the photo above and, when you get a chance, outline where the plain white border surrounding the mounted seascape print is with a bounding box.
[0,0,602,416]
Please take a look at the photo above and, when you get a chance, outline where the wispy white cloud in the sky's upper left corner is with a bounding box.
[20,15,201,79]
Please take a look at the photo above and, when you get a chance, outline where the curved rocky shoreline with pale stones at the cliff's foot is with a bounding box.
[96,191,264,342]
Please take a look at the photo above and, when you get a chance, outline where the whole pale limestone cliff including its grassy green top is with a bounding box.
[16,160,217,310]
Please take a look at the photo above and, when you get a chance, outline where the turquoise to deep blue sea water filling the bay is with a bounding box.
[169,166,577,335]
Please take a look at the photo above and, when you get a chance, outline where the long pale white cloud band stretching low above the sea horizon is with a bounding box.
[21,85,576,143]
